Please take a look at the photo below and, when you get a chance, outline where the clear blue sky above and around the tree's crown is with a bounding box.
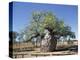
[10,2,78,39]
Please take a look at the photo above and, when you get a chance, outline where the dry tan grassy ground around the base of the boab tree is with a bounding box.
[9,42,78,58]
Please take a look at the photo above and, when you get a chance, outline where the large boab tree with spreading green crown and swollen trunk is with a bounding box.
[21,12,75,52]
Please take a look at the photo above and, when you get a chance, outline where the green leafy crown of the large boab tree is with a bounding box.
[21,12,75,40]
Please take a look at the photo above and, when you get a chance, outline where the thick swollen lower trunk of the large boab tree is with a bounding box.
[41,35,57,52]
